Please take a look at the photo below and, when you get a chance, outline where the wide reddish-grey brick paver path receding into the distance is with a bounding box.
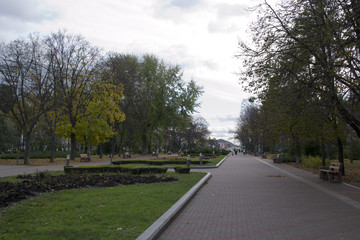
[159,155,360,240]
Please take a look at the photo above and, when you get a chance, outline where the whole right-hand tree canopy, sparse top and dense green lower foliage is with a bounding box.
[238,0,360,172]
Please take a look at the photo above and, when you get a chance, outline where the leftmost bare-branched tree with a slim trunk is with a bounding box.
[0,35,53,164]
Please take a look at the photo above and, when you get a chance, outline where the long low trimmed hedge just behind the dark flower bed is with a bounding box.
[64,166,167,174]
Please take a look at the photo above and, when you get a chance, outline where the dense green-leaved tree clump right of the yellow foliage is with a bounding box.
[106,54,202,154]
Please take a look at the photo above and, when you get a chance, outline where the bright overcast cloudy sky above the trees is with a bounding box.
[0,0,268,141]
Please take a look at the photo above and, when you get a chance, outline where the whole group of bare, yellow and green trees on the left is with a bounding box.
[0,30,202,161]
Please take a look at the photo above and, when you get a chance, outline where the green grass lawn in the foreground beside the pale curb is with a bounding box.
[0,173,205,240]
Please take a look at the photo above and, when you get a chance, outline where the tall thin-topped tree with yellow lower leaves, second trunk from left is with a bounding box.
[46,31,101,159]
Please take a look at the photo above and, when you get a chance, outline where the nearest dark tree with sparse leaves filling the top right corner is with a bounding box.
[236,0,360,172]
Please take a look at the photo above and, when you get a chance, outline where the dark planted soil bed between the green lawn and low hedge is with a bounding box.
[0,172,177,208]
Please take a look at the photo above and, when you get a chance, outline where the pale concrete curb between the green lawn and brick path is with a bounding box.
[137,173,211,240]
